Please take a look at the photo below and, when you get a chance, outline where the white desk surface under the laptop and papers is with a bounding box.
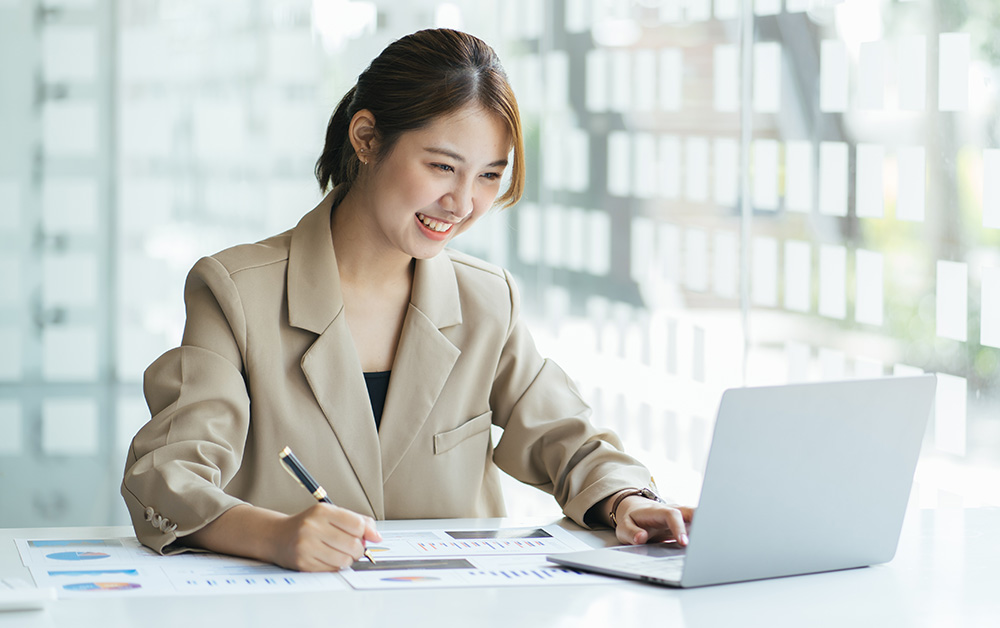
[0,509,1000,628]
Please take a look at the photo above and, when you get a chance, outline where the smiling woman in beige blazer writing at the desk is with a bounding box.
[122,30,691,570]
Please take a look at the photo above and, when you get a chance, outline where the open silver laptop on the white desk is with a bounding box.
[548,375,936,587]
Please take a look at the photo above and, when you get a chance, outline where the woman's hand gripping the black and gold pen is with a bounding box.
[271,504,382,571]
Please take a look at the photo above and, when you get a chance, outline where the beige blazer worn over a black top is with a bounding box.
[122,194,650,553]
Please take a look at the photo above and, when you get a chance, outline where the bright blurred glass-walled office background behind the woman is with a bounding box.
[0,0,1000,527]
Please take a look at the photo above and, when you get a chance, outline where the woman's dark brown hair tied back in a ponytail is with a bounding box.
[316,28,524,207]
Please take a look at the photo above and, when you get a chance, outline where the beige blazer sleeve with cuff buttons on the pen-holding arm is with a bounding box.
[121,257,250,554]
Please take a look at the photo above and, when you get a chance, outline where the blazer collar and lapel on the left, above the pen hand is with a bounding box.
[288,197,385,519]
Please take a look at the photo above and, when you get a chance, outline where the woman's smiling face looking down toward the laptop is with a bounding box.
[362,106,511,259]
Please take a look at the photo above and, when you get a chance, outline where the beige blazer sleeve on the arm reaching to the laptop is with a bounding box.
[490,271,651,527]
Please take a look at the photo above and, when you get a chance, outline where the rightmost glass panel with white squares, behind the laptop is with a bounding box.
[747,0,1000,505]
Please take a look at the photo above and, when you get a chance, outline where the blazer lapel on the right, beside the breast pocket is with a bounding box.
[379,252,462,479]
